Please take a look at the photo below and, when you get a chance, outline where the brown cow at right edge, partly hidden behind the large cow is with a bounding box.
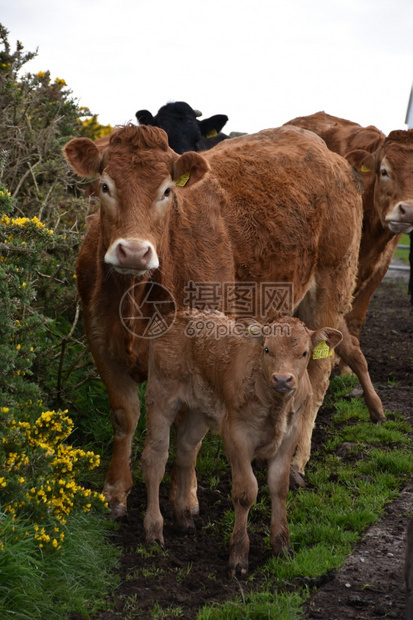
[287,112,413,358]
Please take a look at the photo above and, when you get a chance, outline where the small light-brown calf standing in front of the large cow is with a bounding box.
[142,312,342,575]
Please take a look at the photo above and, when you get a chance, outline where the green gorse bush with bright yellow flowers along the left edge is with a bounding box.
[0,186,108,549]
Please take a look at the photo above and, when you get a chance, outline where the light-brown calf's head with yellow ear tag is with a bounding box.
[249,317,343,397]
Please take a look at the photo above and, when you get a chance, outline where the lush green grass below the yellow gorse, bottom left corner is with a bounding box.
[0,514,119,620]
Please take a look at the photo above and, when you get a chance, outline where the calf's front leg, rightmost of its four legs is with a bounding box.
[268,425,298,555]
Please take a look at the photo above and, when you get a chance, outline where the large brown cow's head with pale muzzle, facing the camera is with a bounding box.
[64,125,209,275]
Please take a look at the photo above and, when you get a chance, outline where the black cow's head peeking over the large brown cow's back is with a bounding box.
[135,101,228,154]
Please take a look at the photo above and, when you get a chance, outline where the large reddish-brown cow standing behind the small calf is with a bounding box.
[65,125,382,515]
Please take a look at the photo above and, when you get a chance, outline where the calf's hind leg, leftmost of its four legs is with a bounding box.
[142,398,178,544]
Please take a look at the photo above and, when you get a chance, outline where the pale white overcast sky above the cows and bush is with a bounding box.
[0,0,413,133]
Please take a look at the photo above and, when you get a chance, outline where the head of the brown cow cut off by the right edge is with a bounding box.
[346,130,413,234]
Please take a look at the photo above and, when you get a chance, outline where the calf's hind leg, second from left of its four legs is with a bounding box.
[174,410,208,531]
